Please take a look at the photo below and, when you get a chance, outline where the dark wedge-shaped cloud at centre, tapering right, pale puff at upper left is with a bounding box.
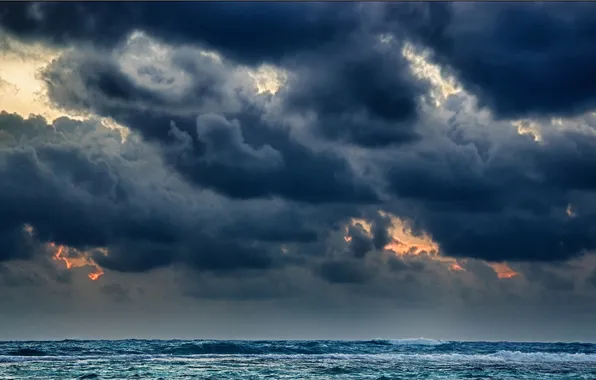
[166,115,377,203]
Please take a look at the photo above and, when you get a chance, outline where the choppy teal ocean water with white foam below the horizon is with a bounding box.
[0,339,596,380]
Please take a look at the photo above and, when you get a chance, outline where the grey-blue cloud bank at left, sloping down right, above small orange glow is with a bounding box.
[0,113,322,271]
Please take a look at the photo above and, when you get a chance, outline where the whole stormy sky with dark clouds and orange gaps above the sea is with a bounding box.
[0,2,596,341]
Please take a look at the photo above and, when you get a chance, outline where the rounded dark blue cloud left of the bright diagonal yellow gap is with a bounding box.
[280,33,427,148]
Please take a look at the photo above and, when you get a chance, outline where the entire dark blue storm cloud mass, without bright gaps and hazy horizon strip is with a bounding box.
[0,3,596,294]
